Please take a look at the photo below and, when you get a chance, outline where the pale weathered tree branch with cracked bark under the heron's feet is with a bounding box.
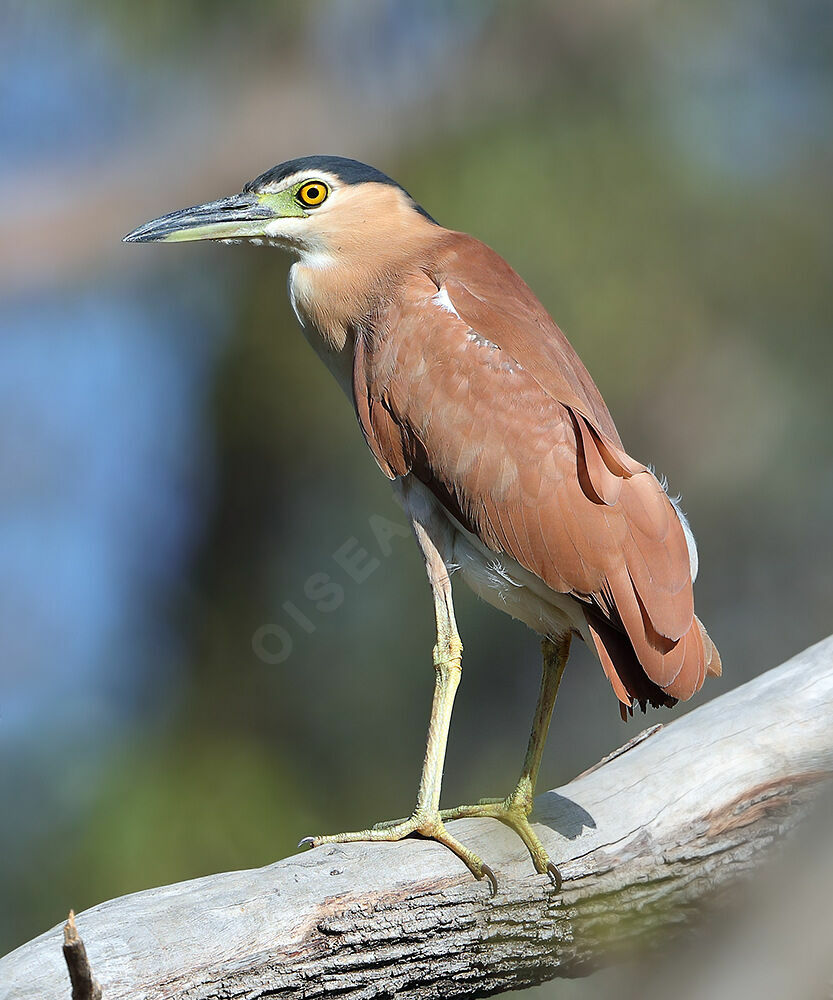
[0,637,833,1000]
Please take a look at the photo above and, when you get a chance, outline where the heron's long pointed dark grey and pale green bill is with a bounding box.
[124,193,278,243]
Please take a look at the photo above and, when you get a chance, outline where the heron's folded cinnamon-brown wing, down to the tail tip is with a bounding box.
[354,234,719,707]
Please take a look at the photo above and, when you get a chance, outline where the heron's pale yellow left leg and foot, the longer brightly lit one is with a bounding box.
[299,508,497,894]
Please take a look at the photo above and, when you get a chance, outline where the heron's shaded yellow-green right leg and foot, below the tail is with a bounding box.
[440,632,570,888]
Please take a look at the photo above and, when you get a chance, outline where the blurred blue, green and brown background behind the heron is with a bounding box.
[0,0,833,992]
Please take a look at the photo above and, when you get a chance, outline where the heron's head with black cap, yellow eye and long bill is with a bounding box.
[124,156,433,256]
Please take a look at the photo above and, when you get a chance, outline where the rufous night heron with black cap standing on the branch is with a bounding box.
[125,156,720,889]
